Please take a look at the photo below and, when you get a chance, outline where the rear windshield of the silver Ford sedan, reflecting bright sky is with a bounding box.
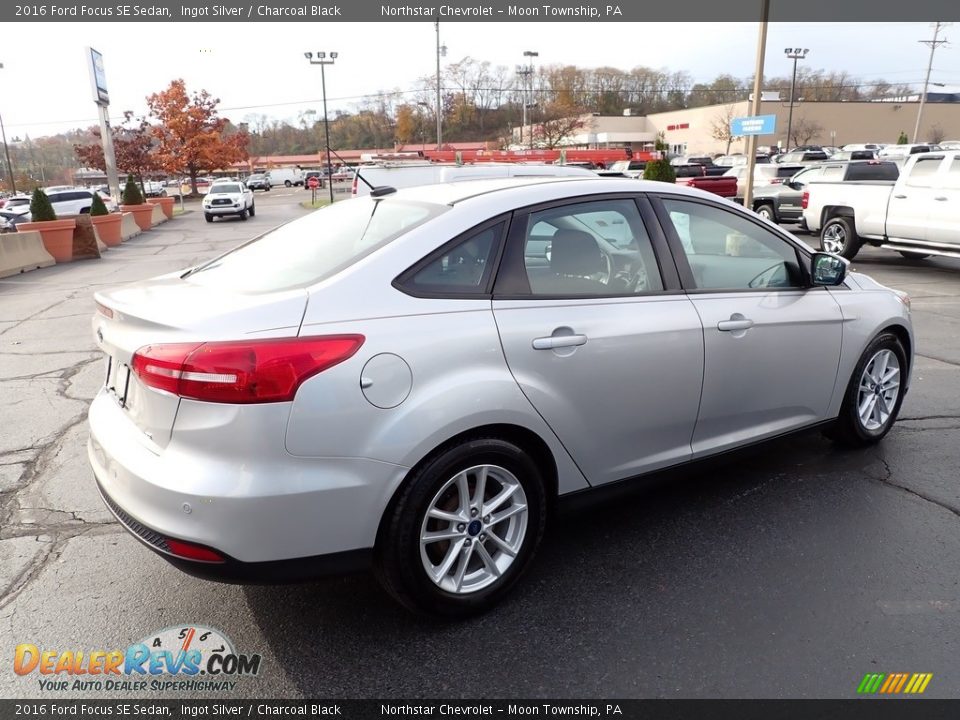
[184,198,449,293]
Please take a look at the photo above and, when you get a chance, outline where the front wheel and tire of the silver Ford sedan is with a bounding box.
[827,333,908,447]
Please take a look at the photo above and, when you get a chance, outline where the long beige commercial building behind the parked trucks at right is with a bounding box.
[514,100,960,155]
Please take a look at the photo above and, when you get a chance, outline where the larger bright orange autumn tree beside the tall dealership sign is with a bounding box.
[147,80,249,195]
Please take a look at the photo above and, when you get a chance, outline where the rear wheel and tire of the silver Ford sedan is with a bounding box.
[374,437,547,617]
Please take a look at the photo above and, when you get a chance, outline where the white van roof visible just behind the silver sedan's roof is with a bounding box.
[352,163,597,197]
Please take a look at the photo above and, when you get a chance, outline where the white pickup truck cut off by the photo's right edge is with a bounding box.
[803,150,960,260]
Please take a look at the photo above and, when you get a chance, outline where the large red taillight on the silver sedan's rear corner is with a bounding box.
[132,335,364,404]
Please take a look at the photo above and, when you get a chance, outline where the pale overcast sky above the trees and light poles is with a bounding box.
[0,20,960,138]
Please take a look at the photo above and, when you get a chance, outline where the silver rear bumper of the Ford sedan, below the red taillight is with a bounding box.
[87,391,408,581]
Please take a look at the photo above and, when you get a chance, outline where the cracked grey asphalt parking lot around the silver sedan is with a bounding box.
[0,189,960,698]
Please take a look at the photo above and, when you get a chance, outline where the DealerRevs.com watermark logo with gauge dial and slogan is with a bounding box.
[13,625,262,692]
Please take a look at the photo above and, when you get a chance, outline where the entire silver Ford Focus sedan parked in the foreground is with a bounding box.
[89,179,914,615]
